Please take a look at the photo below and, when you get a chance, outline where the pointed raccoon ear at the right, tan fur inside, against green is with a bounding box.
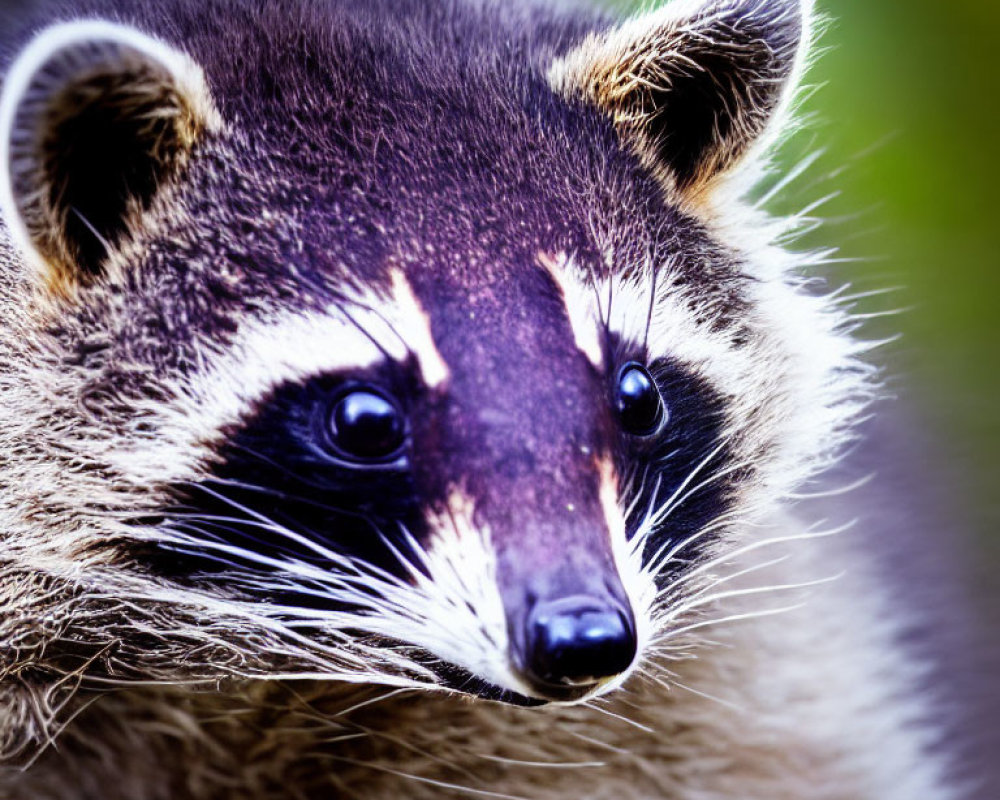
[549,0,812,198]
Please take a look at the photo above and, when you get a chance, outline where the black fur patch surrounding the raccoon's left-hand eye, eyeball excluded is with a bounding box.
[144,365,426,606]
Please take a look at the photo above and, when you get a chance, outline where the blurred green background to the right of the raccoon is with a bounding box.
[616,0,1000,572]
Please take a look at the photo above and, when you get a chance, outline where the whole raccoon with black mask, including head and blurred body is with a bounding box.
[0,0,959,800]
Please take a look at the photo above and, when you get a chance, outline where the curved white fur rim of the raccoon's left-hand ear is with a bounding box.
[0,19,221,273]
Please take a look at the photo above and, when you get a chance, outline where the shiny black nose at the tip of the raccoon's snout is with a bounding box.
[522,596,636,691]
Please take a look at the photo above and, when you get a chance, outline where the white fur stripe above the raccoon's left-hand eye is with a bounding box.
[110,273,448,484]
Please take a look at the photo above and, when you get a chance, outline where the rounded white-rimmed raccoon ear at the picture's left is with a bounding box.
[0,20,219,295]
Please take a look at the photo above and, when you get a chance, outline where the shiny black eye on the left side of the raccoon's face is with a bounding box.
[327,388,406,462]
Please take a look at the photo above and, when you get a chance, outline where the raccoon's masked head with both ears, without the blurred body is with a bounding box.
[0,0,858,703]
